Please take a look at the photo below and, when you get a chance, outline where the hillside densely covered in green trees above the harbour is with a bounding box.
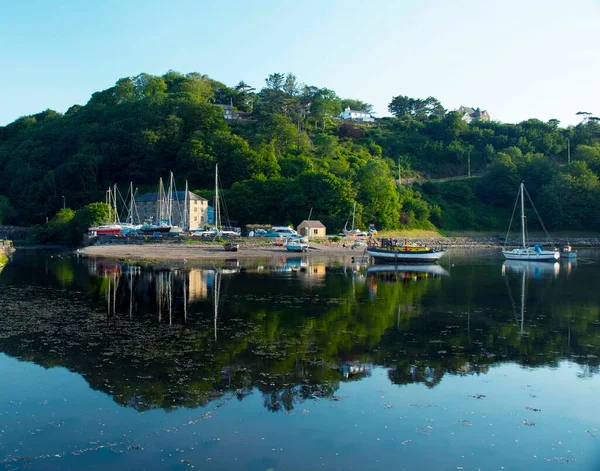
[0,71,600,234]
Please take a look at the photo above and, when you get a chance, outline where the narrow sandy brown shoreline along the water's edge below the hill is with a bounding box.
[79,237,600,262]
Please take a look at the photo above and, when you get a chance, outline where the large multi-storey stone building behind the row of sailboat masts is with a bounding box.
[135,191,208,231]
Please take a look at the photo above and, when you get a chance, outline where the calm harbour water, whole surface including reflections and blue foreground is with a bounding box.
[0,250,600,471]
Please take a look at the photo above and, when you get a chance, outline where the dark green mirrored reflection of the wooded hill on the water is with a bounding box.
[0,254,600,411]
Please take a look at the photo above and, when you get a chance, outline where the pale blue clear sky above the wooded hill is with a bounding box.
[0,0,600,125]
